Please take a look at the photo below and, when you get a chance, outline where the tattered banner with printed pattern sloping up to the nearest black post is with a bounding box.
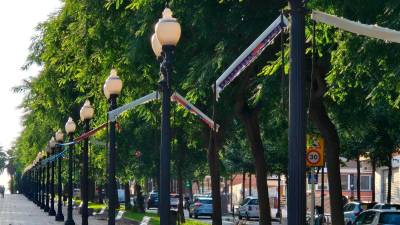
[216,15,288,99]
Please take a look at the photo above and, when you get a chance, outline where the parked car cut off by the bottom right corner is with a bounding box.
[354,209,400,225]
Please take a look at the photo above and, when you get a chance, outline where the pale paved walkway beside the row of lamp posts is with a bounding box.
[0,195,107,225]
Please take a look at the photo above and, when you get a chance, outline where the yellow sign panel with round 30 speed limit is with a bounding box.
[306,134,325,167]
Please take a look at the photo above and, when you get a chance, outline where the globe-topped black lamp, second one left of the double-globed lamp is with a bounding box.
[80,100,94,225]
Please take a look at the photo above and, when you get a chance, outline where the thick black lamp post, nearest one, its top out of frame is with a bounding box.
[287,0,306,225]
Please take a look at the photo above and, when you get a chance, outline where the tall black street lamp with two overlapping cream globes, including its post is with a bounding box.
[151,8,181,225]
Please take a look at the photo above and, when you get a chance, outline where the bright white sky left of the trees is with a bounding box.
[0,0,62,190]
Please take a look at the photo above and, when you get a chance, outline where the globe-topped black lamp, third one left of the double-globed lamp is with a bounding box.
[65,117,76,225]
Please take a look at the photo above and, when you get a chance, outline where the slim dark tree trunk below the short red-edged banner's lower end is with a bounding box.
[208,135,222,225]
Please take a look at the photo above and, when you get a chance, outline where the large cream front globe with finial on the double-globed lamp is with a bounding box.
[155,8,181,46]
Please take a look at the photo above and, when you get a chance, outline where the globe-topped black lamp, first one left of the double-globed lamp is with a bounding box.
[103,69,122,225]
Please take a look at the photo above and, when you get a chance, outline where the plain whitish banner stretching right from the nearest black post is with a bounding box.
[311,10,400,43]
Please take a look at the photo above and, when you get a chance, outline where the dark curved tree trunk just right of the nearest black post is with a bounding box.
[309,63,344,225]
